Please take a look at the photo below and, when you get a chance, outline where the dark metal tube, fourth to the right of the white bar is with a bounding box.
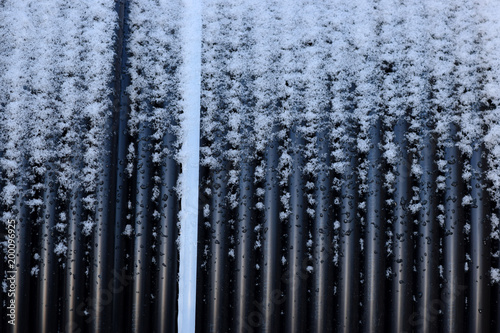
[284,126,309,332]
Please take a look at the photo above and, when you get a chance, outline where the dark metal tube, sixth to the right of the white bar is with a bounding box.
[336,143,360,333]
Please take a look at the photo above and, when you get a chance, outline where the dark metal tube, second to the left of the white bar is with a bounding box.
[132,121,153,333]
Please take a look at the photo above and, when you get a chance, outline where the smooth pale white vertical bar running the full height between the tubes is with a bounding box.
[178,0,202,333]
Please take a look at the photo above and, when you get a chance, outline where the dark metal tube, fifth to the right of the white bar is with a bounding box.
[309,132,335,333]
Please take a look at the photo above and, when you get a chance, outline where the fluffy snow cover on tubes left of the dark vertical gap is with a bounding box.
[0,1,116,230]
